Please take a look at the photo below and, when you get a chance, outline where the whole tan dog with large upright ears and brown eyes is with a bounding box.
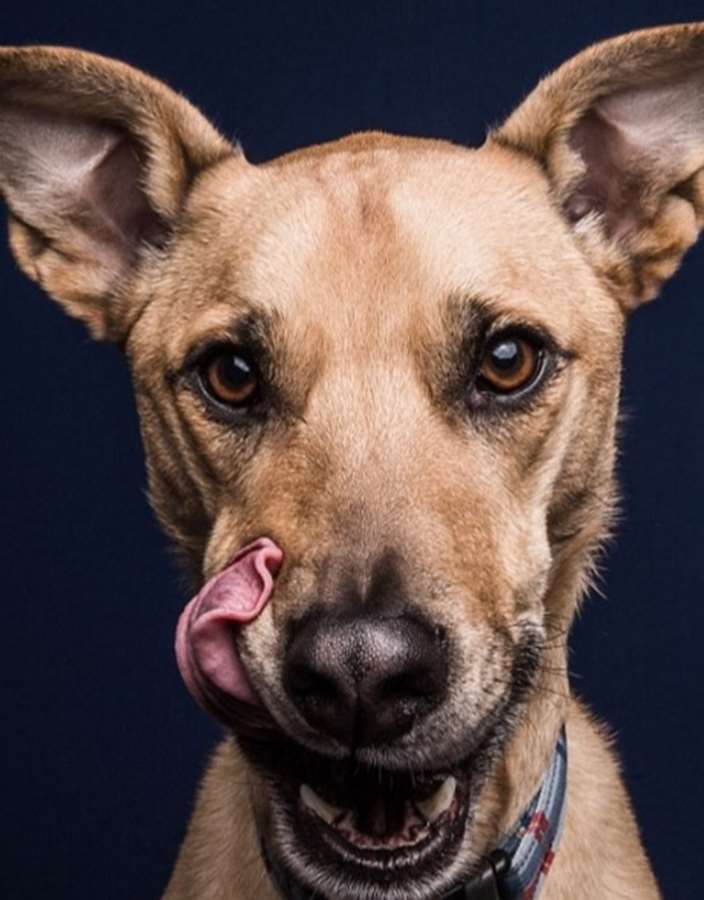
[0,25,704,900]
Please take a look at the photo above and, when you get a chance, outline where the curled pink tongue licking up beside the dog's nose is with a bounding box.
[176,538,283,718]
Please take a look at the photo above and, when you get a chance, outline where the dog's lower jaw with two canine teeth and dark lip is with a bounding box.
[256,740,489,900]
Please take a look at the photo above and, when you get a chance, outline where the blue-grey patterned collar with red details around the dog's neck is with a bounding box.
[262,726,567,900]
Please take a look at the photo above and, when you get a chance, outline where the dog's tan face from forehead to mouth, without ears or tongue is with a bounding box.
[128,136,623,884]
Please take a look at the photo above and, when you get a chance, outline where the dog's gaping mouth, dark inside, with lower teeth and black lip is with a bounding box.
[252,747,470,896]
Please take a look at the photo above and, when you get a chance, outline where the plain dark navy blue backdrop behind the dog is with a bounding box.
[0,0,704,900]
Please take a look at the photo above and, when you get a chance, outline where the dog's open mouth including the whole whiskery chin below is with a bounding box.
[235,724,496,900]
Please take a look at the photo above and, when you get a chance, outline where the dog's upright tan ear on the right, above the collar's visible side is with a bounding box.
[489,23,704,309]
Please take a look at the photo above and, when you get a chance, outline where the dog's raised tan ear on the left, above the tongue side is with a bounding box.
[0,47,235,340]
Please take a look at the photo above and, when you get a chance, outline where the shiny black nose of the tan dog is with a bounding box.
[284,613,447,747]
